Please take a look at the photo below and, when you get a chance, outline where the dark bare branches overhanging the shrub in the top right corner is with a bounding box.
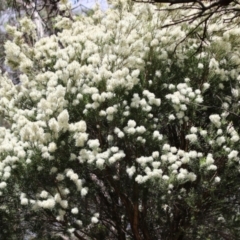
[133,0,240,48]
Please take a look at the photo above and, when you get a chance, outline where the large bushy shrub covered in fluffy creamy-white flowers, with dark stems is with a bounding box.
[0,1,240,240]
